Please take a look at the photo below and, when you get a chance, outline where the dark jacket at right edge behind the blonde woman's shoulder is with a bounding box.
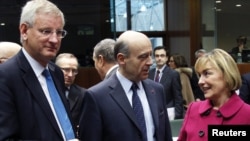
[239,73,250,104]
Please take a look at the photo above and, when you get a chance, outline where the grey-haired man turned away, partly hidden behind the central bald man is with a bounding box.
[93,38,118,80]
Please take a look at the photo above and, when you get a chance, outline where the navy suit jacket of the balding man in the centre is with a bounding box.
[80,75,172,141]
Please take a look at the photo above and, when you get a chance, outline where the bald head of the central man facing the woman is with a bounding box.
[114,31,152,82]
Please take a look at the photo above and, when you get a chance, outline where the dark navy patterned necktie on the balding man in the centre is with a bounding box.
[131,83,147,141]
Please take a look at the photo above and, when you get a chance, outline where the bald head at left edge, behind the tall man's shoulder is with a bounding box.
[0,42,22,64]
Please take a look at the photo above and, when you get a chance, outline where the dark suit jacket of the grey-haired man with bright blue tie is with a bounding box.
[0,51,75,141]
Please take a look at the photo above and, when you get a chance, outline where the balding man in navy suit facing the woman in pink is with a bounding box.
[80,31,172,141]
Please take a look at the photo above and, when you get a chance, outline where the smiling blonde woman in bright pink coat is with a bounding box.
[178,49,250,141]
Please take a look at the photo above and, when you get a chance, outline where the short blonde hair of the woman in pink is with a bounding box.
[194,48,242,91]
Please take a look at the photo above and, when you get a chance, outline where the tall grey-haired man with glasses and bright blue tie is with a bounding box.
[0,1,75,141]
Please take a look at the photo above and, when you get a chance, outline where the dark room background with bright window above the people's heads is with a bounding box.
[0,0,250,88]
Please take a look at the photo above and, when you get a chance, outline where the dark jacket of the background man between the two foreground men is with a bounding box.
[68,84,86,133]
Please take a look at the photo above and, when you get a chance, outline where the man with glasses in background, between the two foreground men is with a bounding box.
[55,53,86,137]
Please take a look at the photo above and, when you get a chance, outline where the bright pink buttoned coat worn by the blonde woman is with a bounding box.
[178,93,250,141]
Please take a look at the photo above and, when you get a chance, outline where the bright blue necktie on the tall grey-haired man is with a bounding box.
[42,69,75,140]
